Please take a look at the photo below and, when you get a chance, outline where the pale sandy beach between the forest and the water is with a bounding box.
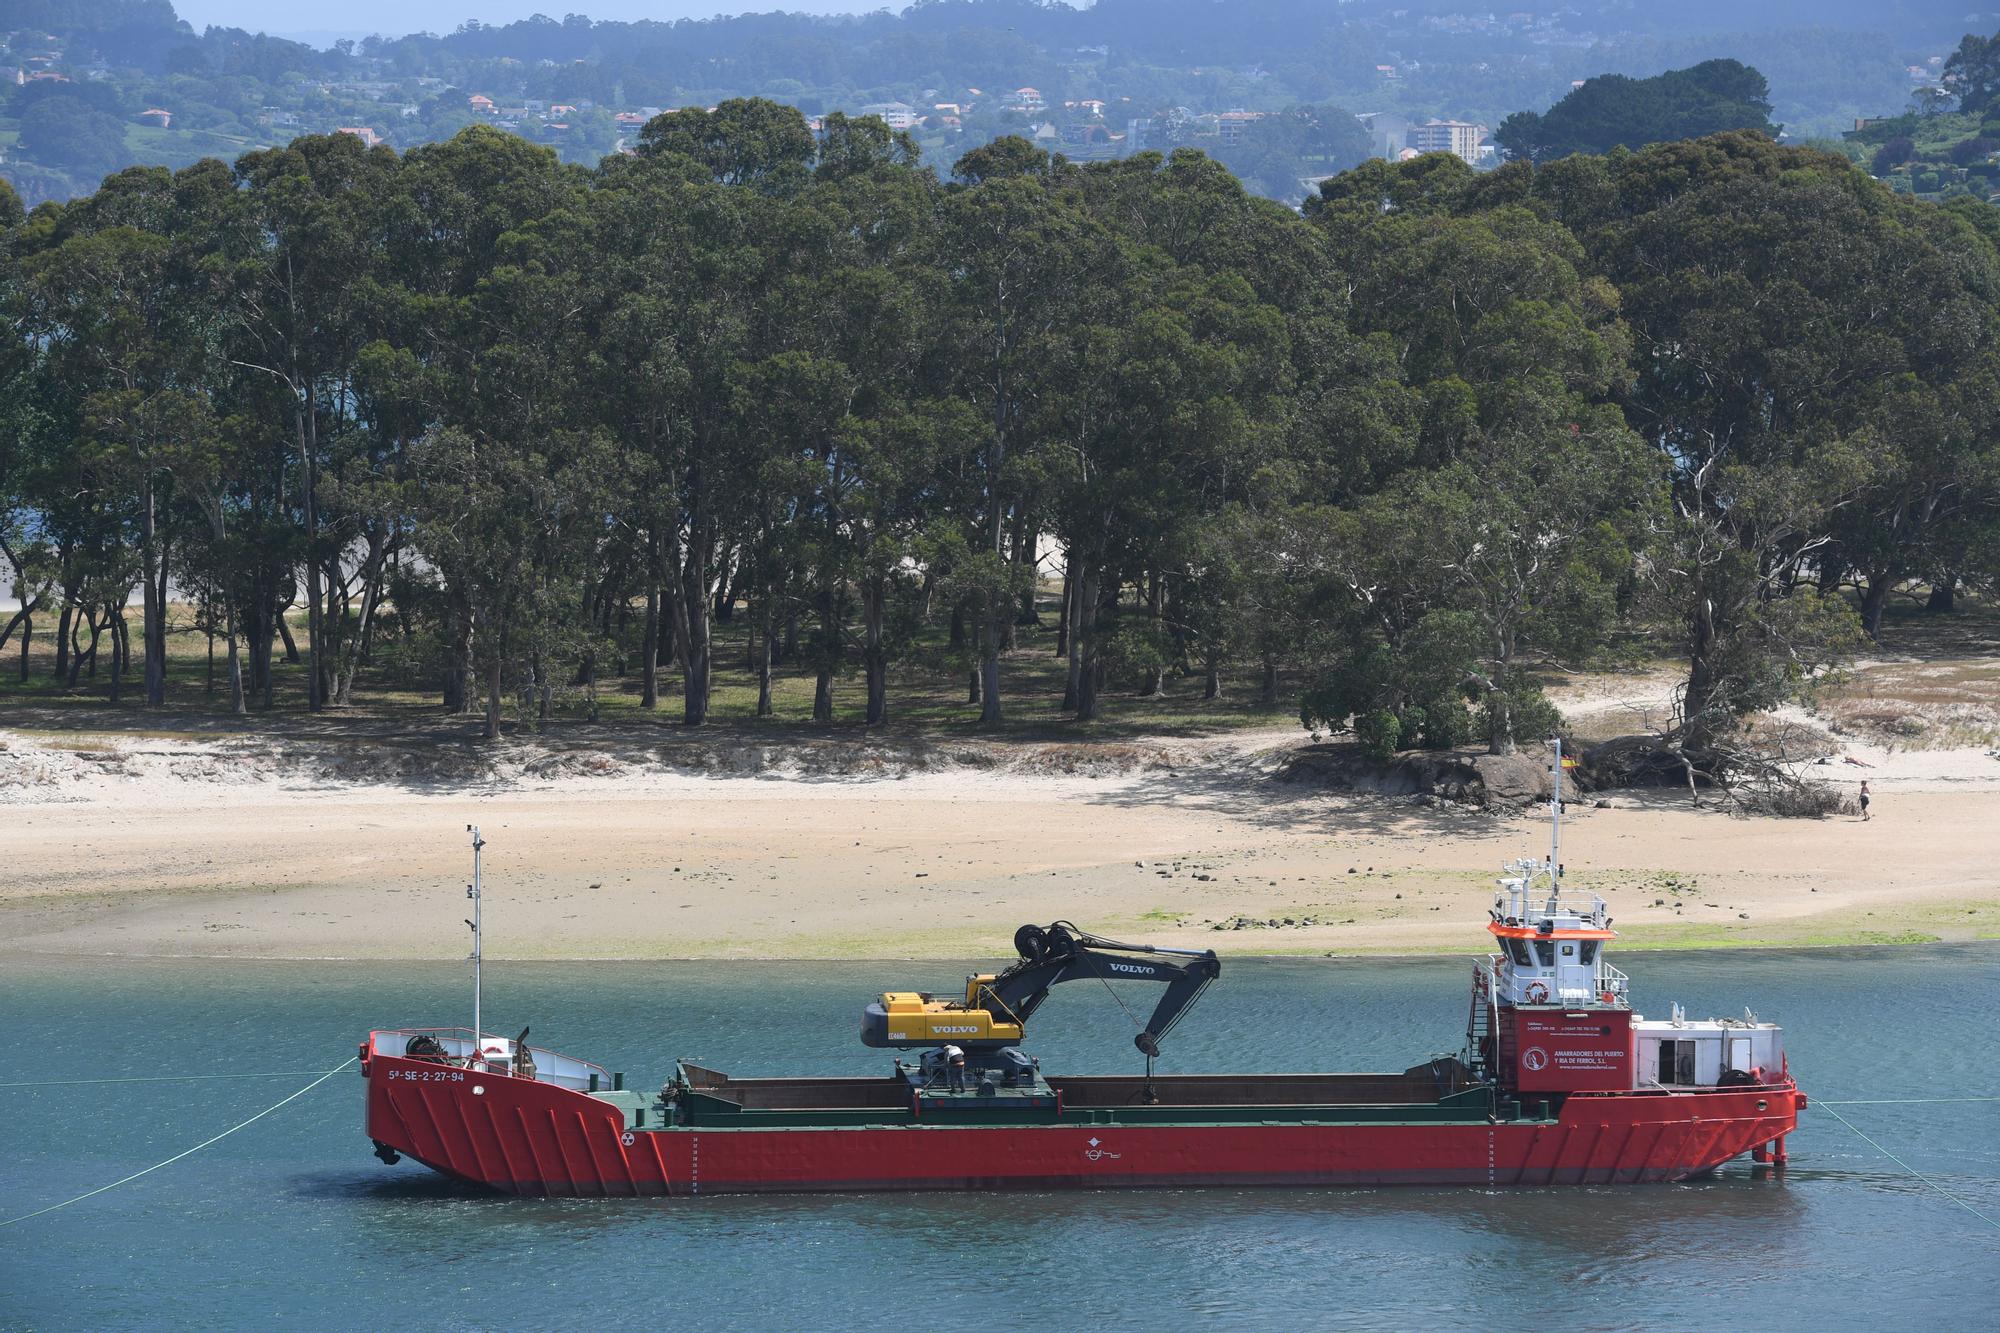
[0,716,2000,959]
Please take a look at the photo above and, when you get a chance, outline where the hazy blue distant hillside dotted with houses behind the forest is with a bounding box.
[0,0,1960,204]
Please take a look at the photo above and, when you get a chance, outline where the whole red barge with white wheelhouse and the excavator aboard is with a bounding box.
[360,784,1806,1197]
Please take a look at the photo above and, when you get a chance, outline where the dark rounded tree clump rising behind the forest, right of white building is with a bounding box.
[1494,60,1778,162]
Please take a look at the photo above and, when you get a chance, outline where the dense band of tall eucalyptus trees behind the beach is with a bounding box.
[0,111,2000,788]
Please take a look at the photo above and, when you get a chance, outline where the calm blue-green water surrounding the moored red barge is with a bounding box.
[0,945,2000,1331]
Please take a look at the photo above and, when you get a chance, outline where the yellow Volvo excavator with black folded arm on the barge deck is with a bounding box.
[862,921,1222,1067]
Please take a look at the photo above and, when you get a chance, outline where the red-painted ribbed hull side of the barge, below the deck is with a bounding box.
[362,1047,1806,1197]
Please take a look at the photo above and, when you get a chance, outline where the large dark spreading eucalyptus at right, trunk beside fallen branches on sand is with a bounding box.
[1544,134,1994,743]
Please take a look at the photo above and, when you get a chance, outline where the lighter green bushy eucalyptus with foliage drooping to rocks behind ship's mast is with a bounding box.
[1318,188,1660,753]
